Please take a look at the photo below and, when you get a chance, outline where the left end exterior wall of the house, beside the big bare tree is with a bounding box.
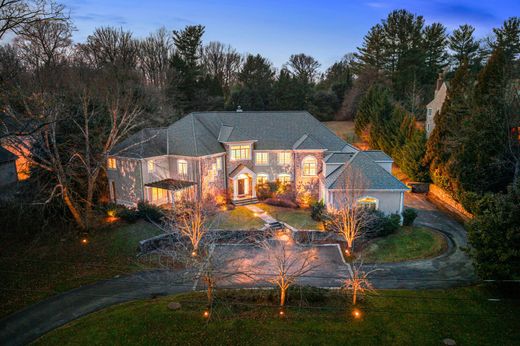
[107,158,144,206]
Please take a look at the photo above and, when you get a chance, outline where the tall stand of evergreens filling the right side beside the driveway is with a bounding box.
[355,11,520,278]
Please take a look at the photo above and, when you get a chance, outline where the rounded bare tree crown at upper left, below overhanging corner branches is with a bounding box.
[15,16,73,70]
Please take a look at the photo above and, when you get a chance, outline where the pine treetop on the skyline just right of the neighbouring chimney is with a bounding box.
[448,24,480,70]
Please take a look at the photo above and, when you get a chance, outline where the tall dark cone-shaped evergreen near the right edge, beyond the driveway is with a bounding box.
[456,49,514,194]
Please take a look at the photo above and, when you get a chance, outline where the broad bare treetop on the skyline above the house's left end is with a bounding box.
[77,27,139,69]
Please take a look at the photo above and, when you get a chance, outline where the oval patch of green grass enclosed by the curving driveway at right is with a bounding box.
[362,227,447,263]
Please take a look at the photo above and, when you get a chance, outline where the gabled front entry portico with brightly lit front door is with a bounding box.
[229,164,257,204]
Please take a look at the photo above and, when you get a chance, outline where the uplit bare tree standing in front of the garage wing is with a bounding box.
[329,164,373,256]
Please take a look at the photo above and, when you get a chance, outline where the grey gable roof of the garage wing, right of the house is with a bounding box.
[326,151,409,191]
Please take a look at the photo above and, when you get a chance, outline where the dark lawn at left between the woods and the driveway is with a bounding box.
[0,221,161,316]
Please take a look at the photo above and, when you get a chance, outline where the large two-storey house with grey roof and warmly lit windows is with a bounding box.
[107,110,408,213]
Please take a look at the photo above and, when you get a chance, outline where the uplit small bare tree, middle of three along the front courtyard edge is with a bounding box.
[256,237,317,307]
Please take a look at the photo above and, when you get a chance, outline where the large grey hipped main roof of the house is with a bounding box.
[112,112,351,158]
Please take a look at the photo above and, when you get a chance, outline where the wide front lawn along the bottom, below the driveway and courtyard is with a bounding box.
[36,287,520,345]
